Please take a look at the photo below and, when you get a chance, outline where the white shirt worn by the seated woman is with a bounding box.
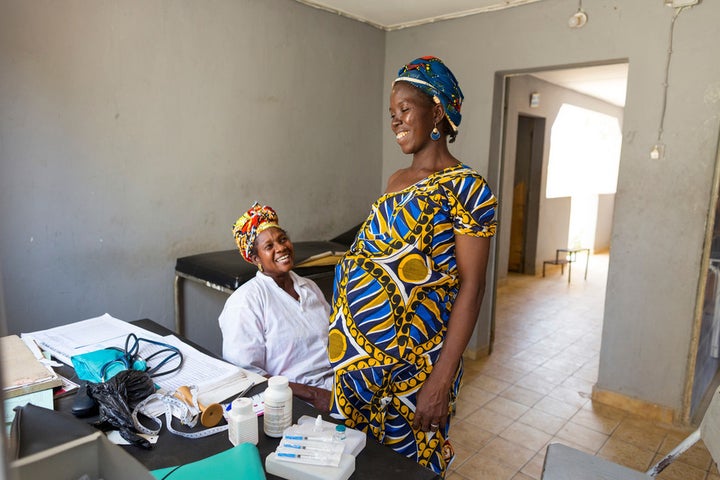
[218,271,332,389]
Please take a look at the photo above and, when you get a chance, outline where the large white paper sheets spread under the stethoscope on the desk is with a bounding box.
[22,313,266,405]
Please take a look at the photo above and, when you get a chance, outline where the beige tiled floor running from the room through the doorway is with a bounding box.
[446,255,720,480]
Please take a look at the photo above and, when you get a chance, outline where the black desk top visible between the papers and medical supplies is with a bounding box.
[55,319,440,480]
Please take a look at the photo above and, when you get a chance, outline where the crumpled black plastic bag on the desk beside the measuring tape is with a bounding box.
[88,370,155,449]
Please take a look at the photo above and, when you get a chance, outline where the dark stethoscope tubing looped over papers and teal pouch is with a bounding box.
[100,333,184,382]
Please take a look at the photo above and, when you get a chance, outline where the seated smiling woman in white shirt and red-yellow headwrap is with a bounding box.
[219,202,333,412]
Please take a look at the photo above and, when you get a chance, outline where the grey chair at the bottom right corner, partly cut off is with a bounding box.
[541,387,720,480]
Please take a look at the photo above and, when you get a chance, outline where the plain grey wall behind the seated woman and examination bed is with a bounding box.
[0,0,385,344]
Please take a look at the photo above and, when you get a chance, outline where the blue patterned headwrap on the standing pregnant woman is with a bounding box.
[393,56,464,132]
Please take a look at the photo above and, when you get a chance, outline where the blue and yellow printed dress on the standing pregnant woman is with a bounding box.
[328,164,497,474]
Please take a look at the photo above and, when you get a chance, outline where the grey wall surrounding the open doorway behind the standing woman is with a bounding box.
[383,0,720,410]
